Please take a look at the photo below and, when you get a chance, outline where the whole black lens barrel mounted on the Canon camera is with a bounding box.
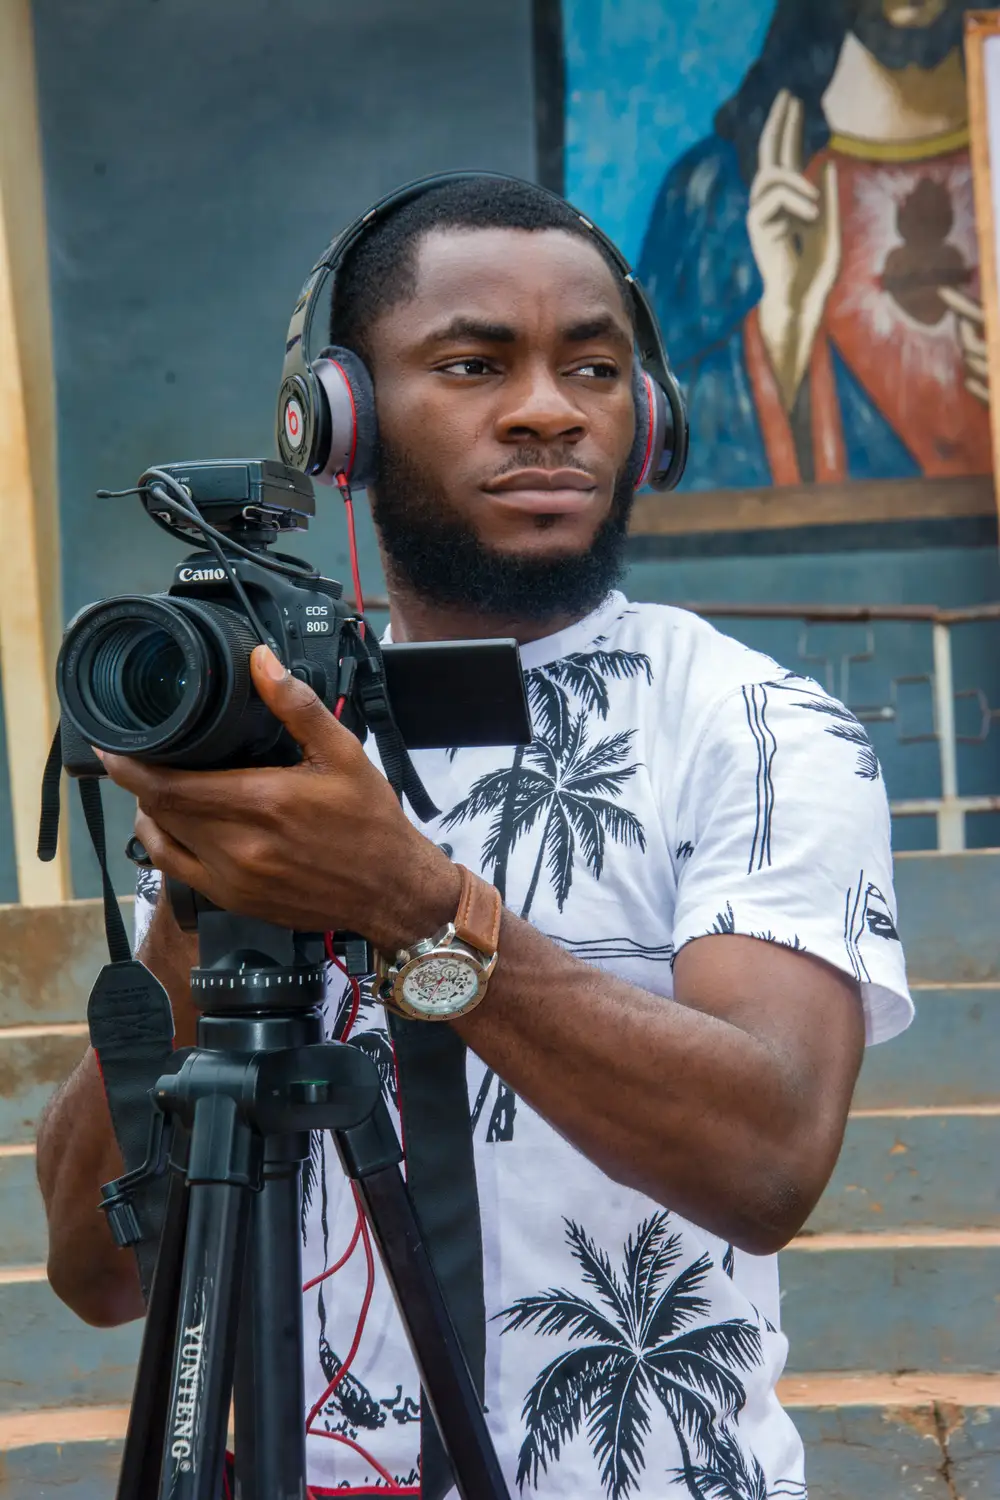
[55,594,282,767]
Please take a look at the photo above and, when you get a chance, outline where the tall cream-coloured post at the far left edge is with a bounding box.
[0,0,70,906]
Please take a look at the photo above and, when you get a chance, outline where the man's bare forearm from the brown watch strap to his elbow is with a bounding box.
[454,912,855,1253]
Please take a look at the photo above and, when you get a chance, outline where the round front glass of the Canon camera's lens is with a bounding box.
[90,621,187,731]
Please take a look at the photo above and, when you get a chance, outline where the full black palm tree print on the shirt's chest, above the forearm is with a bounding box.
[442,713,646,1140]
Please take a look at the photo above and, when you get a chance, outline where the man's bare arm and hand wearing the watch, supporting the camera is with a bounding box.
[97,660,864,1253]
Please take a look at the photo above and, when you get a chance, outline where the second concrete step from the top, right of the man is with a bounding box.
[855,984,1000,1109]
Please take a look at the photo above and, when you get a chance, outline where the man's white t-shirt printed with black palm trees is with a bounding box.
[136,594,913,1500]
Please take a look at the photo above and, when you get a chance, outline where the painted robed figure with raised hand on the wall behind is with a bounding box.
[639,0,993,489]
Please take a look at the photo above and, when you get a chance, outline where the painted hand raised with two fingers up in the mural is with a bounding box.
[747,89,841,410]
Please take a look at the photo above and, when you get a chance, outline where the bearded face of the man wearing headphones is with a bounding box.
[369,220,634,618]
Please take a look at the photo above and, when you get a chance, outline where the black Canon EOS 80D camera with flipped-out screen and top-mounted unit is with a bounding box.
[55,459,531,786]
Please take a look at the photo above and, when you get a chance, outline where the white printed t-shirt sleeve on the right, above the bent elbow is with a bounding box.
[673,674,913,1043]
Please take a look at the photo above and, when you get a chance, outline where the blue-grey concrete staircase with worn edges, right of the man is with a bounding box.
[779,851,1000,1500]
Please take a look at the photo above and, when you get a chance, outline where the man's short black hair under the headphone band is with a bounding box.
[330,177,634,359]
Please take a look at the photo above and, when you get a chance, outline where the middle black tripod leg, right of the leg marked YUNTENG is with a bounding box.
[235,1142,309,1500]
